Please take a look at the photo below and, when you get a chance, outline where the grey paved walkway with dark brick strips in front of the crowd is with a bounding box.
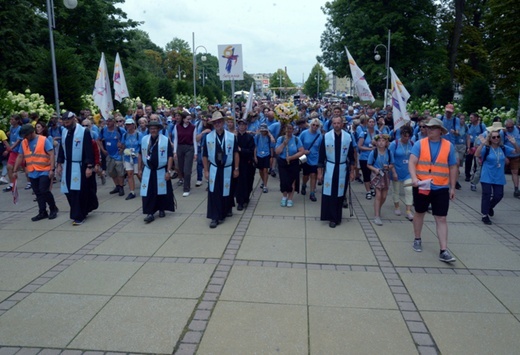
[0,176,520,355]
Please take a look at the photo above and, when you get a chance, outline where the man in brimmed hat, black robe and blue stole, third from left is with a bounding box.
[202,111,240,228]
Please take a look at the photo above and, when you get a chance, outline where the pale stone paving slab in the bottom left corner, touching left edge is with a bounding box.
[0,293,109,348]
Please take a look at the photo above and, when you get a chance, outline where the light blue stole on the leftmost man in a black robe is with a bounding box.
[60,124,85,194]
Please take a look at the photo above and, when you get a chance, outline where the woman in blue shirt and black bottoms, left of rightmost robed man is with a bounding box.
[275,124,303,207]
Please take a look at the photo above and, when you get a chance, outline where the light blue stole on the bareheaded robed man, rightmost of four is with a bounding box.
[323,130,351,197]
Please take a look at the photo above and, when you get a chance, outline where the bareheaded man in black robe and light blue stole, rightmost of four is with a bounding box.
[318,116,356,228]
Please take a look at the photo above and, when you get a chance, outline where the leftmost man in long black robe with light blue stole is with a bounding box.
[56,111,98,226]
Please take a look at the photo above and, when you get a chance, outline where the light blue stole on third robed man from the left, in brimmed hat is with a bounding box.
[206,131,235,196]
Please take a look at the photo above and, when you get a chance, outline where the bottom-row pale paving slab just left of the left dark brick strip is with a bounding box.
[68,297,195,354]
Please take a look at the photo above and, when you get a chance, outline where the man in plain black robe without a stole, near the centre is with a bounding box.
[235,120,255,211]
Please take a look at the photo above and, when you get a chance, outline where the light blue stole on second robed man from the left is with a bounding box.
[141,134,169,197]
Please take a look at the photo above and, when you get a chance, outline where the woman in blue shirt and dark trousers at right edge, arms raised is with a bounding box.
[475,127,520,225]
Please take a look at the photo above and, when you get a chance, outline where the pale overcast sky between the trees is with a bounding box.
[119,0,326,82]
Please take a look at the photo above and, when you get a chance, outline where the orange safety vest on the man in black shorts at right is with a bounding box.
[416,138,450,186]
